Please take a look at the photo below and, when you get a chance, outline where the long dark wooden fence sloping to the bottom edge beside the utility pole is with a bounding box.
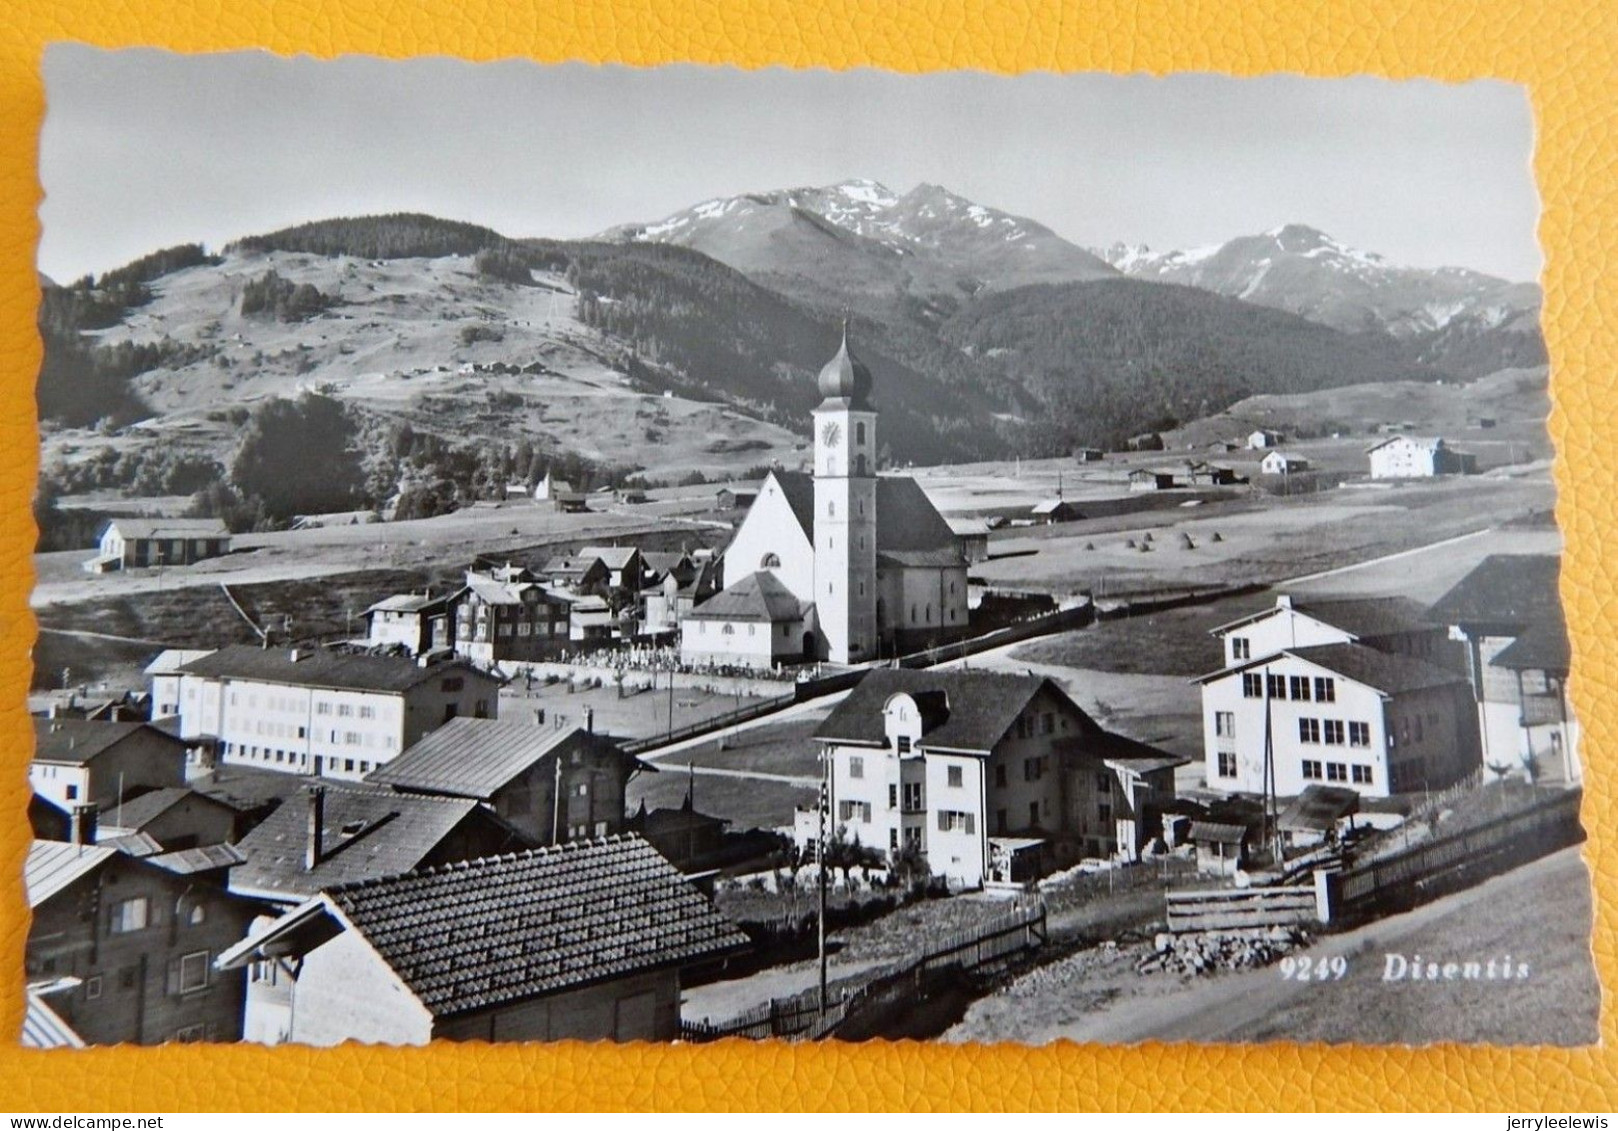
[680,903,1045,1044]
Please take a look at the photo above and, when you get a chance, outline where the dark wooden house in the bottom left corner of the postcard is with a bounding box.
[24,840,259,1045]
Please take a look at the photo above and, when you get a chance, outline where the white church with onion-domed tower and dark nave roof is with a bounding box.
[680,325,968,668]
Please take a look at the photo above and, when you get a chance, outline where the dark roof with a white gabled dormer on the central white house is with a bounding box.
[814,668,1054,751]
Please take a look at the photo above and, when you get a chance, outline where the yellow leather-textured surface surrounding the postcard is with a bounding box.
[0,0,1618,1113]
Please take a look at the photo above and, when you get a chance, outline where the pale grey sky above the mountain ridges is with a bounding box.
[39,45,1542,282]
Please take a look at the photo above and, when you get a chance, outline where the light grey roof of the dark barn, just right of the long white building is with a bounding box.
[366,715,628,801]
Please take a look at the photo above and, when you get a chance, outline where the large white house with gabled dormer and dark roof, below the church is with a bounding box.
[796,668,1188,887]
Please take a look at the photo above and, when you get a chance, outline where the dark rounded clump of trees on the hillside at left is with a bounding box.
[230,393,366,521]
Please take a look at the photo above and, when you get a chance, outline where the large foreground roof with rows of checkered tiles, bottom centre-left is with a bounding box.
[325,837,748,1018]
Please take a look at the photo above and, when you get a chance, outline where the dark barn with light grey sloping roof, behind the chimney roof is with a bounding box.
[366,718,641,845]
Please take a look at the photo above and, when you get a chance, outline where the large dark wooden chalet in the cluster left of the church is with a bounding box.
[448,570,573,668]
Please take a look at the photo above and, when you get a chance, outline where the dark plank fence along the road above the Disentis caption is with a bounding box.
[1322,790,1584,919]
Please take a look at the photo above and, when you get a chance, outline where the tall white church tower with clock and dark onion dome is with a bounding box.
[814,320,877,663]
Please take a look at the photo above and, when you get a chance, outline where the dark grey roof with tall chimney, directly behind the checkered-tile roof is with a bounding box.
[230,783,514,900]
